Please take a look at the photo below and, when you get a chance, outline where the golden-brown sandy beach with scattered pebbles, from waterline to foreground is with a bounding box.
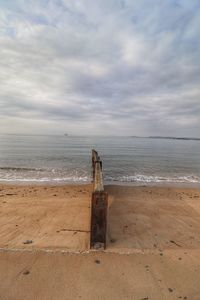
[0,185,200,300]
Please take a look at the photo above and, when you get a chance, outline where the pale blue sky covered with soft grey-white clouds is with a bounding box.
[0,0,200,137]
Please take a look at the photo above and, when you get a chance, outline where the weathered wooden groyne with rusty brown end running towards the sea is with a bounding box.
[90,150,108,249]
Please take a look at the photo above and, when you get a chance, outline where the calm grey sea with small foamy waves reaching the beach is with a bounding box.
[0,135,200,184]
